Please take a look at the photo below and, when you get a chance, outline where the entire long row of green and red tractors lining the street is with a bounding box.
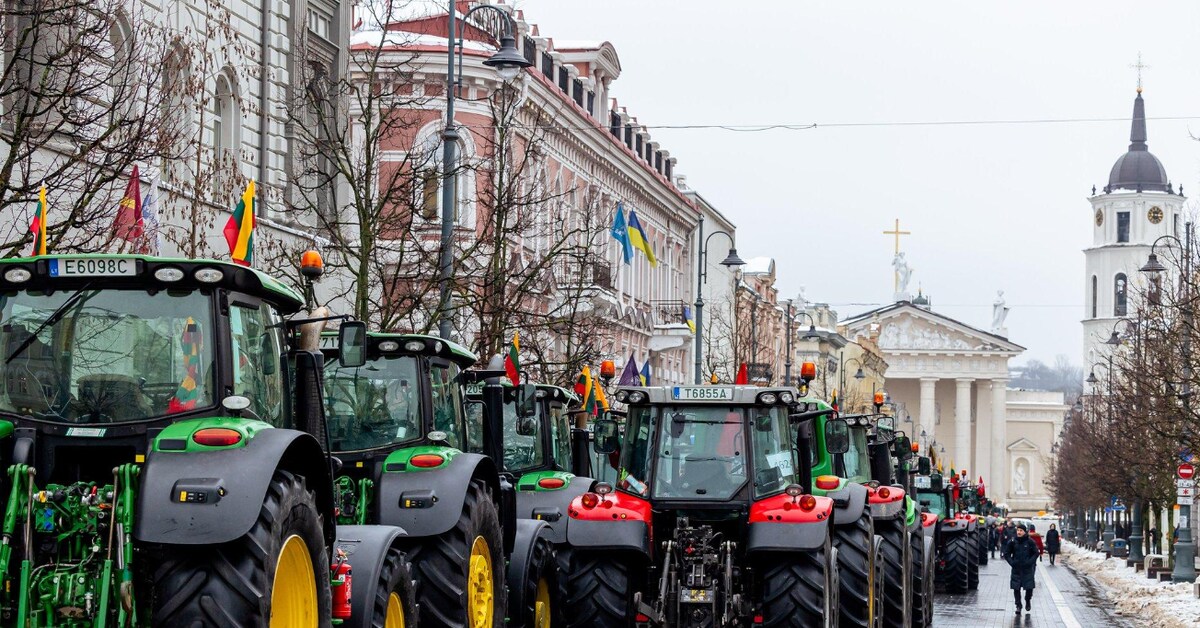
[0,253,988,628]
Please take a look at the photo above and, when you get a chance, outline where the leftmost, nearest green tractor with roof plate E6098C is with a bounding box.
[0,253,415,628]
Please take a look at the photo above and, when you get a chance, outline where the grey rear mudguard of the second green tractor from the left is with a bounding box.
[376,453,500,537]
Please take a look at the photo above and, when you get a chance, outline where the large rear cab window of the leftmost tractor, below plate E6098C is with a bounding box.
[0,288,214,424]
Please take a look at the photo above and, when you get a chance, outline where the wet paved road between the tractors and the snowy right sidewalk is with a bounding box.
[934,557,1130,628]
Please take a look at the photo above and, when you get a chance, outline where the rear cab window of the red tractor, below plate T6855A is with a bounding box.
[620,406,748,500]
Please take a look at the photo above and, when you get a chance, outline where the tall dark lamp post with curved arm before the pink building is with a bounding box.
[438,0,533,340]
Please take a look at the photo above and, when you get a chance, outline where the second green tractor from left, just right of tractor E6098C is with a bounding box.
[324,333,558,628]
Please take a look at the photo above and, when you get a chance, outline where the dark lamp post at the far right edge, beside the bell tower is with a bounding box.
[1141,222,1196,582]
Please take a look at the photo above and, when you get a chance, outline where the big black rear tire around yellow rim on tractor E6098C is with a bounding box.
[151,471,332,628]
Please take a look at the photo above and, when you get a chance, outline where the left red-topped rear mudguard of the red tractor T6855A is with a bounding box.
[566,491,653,556]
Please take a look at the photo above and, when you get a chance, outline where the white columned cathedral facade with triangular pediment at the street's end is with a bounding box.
[844,299,1025,506]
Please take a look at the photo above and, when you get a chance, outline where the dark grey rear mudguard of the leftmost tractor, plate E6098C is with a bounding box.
[133,429,334,545]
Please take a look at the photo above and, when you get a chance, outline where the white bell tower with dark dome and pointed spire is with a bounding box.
[1082,88,1186,377]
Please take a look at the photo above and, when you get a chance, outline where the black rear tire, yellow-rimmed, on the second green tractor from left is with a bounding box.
[406,479,506,628]
